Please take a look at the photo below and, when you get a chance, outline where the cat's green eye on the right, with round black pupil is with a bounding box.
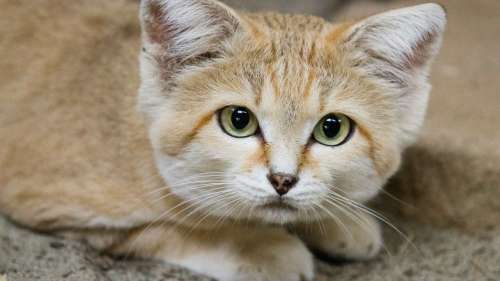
[313,113,353,146]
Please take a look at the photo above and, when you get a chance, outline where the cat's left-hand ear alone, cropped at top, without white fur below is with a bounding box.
[141,0,239,62]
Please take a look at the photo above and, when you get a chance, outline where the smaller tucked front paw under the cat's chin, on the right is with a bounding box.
[294,213,383,261]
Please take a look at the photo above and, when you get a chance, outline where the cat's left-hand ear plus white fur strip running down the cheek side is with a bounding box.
[139,0,240,122]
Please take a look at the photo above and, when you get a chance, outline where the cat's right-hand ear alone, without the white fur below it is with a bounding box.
[344,4,446,87]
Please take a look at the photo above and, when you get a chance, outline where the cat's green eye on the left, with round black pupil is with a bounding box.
[219,105,259,138]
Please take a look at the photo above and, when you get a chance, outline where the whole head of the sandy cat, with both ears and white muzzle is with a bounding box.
[139,0,446,223]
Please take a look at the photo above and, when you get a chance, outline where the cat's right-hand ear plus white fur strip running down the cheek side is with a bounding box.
[340,4,446,147]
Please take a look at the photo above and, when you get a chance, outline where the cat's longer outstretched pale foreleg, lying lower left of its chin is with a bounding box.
[114,223,314,281]
